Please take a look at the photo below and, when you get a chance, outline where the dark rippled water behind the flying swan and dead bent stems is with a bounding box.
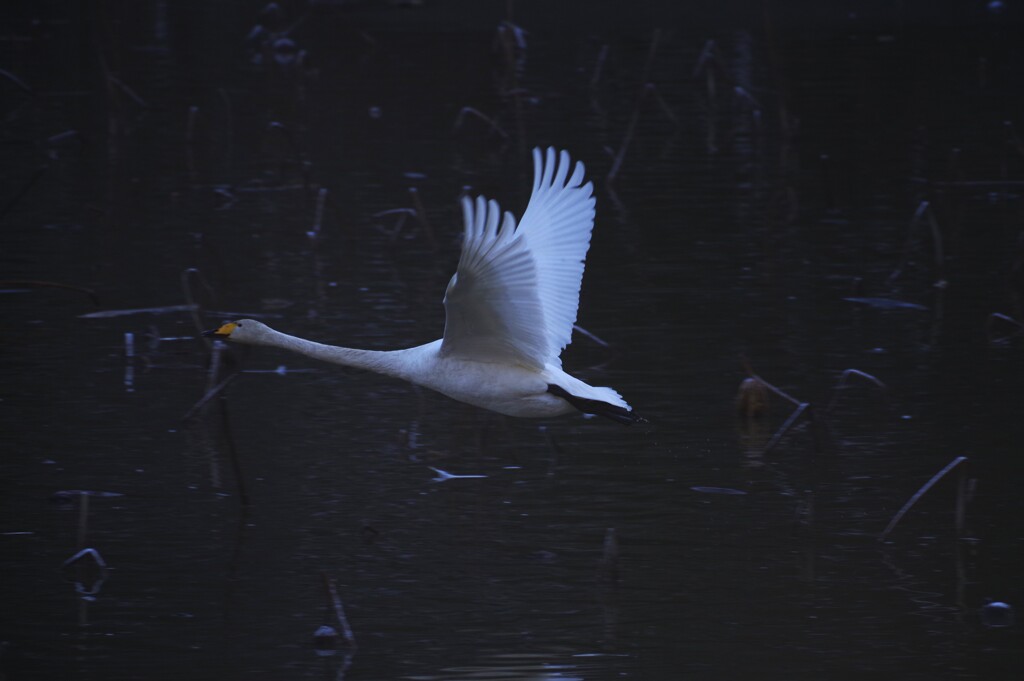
[0,1,1024,679]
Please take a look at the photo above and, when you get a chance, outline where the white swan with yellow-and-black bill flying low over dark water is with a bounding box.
[204,147,644,424]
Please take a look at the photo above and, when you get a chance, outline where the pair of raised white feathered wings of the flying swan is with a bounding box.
[441,148,594,369]
